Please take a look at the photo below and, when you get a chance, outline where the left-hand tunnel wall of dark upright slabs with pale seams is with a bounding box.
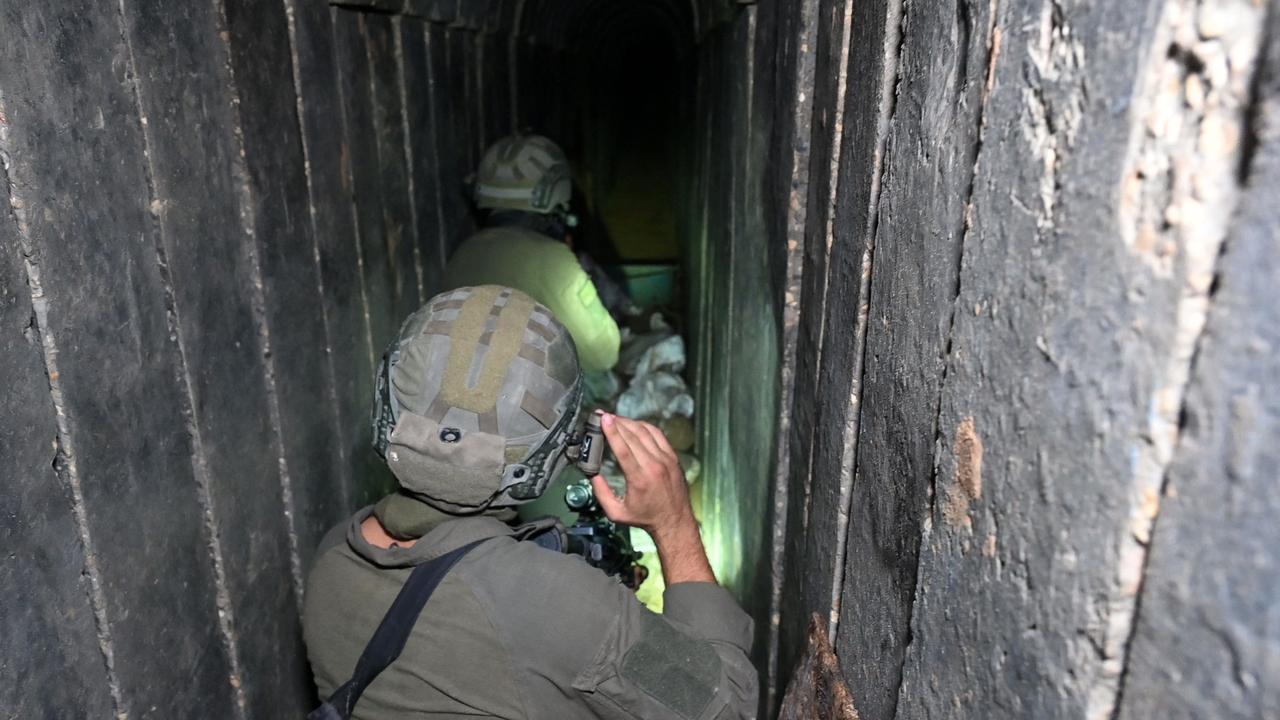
[0,0,550,717]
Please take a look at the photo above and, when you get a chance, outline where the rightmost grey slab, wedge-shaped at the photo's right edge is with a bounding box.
[1119,9,1280,719]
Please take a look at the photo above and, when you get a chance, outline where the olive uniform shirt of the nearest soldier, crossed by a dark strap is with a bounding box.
[303,507,756,720]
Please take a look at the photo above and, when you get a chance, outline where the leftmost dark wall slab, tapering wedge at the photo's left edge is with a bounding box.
[0,120,119,717]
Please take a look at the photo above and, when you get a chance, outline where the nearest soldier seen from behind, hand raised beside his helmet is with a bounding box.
[303,286,756,720]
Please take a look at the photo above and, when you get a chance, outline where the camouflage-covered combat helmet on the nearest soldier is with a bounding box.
[372,286,582,512]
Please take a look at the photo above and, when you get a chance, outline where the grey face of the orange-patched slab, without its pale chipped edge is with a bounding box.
[899,3,1198,717]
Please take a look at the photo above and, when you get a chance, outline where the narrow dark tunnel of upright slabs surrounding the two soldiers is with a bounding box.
[0,0,1280,720]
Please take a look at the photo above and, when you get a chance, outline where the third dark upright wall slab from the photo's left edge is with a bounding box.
[124,0,316,715]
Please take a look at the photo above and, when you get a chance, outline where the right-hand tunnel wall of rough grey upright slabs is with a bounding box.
[772,0,1280,719]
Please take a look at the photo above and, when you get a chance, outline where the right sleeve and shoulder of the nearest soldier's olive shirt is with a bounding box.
[471,542,758,720]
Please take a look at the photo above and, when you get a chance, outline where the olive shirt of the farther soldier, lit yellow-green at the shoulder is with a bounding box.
[444,227,621,372]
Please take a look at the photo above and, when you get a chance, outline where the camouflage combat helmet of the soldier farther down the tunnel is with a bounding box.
[474,133,573,215]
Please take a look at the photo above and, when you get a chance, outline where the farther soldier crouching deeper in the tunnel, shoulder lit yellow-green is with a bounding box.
[444,135,620,373]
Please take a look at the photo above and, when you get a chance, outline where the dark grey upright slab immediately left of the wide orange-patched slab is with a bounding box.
[835,0,996,717]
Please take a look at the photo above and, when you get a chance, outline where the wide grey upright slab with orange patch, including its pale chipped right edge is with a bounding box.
[899,0,1261,717]
